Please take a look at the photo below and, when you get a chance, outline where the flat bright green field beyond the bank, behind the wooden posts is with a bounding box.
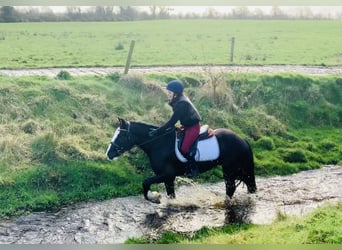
[0,20,342,68]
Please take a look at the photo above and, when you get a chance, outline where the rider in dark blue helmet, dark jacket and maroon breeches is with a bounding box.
[150,80,201,177]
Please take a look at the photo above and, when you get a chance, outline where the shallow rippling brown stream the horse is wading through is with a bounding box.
[0,166,342,244]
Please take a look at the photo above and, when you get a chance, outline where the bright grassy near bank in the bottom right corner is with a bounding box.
[126,204,342,244]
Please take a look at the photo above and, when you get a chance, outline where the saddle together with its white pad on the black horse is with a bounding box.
[175,124,218,162]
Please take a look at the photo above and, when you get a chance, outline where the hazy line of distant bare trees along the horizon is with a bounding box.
[0,6,342,22]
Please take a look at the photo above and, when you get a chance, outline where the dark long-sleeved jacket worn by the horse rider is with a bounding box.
[158,95,201,132]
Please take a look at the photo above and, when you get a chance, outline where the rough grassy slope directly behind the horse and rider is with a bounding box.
[0,72,342,218]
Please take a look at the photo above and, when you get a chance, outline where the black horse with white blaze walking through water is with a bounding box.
[106,118,257,201]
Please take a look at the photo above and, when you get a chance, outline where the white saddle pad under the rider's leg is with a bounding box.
[175,136,220,162]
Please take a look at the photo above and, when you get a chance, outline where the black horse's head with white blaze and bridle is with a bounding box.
[106,118,136,160]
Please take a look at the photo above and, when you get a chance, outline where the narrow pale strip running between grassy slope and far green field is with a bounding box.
[0,65,342,77]
